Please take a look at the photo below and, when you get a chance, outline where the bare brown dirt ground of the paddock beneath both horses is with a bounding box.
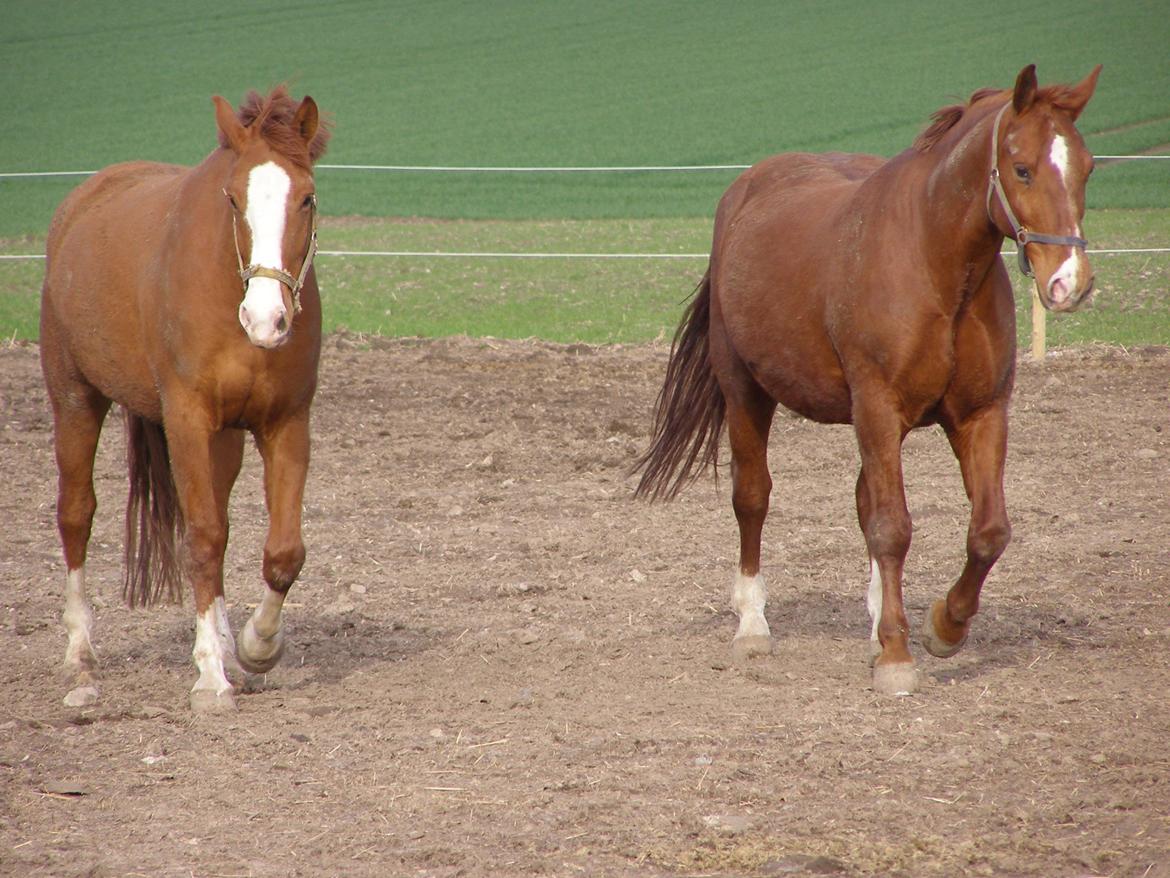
[0,336,1170,878]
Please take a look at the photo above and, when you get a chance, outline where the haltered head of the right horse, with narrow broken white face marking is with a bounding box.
[987,64,1101,311]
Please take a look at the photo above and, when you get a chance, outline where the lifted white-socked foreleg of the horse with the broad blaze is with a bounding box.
[236,410,309,673]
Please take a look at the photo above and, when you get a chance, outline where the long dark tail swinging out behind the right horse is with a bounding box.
[634,269,727,500]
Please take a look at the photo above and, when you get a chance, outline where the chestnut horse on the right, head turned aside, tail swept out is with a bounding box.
[638,66,1101,694]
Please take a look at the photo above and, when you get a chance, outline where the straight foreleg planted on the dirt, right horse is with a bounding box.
[853,398,918,695]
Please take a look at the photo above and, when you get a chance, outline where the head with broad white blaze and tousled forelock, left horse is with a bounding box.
[212,89,324,348]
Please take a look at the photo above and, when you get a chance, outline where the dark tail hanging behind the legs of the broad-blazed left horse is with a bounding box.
[122,411,183,606]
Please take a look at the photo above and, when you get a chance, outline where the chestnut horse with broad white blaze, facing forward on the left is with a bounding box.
[41,87,329,711]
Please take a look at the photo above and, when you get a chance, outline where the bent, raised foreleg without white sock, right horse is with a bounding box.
[922,405,1012,658]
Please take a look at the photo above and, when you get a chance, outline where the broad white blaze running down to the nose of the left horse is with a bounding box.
[241,162,293,344]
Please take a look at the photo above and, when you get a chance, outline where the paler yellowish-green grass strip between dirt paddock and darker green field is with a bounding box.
[0,210,1170,347]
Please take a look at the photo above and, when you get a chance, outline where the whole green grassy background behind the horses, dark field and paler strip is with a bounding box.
[0,0,1170,344]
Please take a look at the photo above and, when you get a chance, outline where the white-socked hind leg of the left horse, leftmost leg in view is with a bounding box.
[49,380,110,707]
